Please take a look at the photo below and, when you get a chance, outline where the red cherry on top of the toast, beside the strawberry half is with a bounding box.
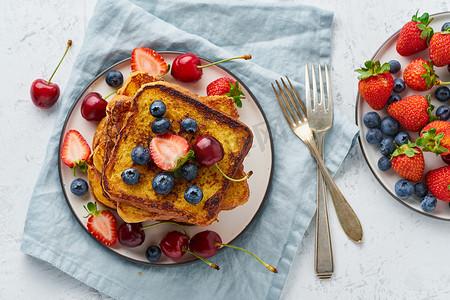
[194,135,224,167]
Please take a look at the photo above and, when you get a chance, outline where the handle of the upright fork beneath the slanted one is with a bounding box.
[314,132,334,279]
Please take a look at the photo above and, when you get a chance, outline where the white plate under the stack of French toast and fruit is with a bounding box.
[59,52,273,265]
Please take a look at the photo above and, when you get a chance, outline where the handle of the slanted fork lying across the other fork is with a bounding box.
[305,136,363,244]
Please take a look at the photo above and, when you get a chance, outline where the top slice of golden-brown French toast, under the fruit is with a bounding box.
[102,81,253,226]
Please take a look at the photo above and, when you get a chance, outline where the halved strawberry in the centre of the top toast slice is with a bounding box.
[150,134,194,171]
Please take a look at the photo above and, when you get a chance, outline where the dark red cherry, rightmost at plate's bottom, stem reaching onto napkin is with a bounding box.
[189,230,278,273]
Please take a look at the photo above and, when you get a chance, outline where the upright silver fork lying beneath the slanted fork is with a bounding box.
[305,64,334,279]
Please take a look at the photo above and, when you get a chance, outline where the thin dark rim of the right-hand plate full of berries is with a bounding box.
[355,11,450,221]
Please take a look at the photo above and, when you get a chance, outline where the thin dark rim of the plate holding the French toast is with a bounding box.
[58,50,274,267]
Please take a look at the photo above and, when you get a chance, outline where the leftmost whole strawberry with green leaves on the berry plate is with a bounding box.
[355,60,394,110]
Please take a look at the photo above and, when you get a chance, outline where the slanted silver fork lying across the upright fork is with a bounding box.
[272,76,363,243]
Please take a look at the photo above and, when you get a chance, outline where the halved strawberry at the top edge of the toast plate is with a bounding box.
[131,47,169,76]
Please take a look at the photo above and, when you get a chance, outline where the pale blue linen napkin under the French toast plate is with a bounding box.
[22,0,358,299]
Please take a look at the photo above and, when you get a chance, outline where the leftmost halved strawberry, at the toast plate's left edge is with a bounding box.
[60,130,91,176]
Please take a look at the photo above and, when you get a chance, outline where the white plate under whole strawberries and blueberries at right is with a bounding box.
[356,12,450,220]
